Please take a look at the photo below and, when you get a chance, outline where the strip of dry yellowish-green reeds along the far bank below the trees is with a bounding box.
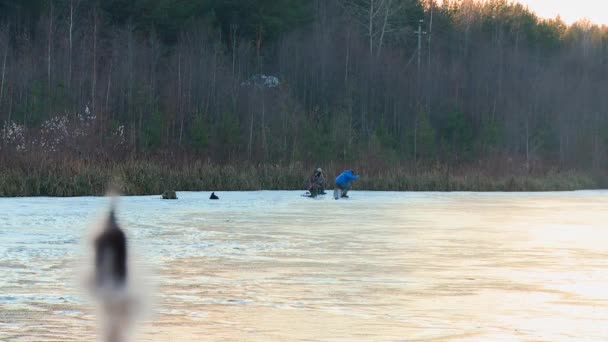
[0,159,608,197]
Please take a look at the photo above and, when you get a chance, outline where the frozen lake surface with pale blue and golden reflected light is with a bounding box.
[0,191,608,341]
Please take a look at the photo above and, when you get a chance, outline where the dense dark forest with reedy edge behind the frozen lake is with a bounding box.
[0,0,608,196]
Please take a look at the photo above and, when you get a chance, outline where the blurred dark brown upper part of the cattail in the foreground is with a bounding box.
[95,208,127,287]
